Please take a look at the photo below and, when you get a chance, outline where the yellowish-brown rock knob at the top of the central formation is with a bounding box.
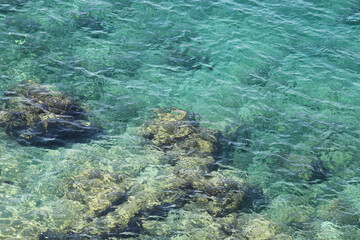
[139,108,220,168]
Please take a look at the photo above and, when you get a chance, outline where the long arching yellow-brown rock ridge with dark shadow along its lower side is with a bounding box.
[72,170,246,237]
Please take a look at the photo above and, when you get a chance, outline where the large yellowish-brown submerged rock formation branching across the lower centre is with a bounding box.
[39,108,288,240]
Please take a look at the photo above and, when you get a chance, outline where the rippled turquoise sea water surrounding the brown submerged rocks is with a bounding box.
[0,0,360,240]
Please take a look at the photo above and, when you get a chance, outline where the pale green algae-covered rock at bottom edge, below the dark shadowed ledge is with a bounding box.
[139,209,292,240]
